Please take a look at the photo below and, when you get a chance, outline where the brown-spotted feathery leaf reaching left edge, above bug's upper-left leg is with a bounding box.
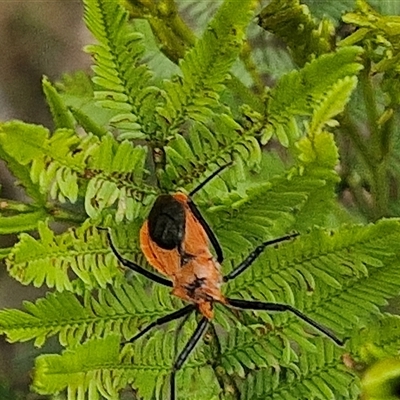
[0,122,155,221]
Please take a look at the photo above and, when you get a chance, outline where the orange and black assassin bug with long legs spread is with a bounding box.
[108,164,343,400]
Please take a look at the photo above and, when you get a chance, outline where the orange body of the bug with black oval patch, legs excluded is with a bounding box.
[140,193,225,319]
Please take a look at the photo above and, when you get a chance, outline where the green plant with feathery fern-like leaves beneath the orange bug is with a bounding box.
[0,0,400,400]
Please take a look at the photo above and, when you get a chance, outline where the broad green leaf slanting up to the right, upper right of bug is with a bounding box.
[261,47,362,146]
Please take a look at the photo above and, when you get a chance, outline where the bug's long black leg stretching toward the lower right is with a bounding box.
[226,299,343,346]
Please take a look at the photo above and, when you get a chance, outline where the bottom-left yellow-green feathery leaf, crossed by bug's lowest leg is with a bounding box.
[34,332,220,400]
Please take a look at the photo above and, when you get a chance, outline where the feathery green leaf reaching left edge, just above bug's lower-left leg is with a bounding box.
[0,277,176,346]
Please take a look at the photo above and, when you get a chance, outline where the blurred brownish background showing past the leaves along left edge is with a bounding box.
[0,0,91,400]
